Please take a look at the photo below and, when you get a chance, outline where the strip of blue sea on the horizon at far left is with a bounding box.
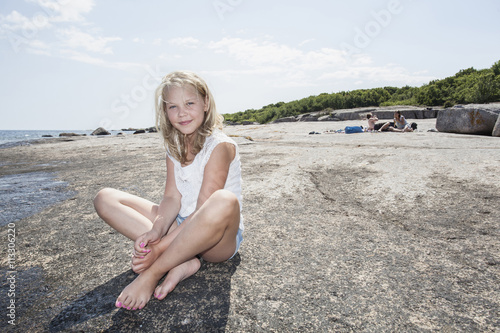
[0,130,124,148]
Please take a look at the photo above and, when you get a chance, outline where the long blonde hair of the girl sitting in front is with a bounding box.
[155,71,224,163]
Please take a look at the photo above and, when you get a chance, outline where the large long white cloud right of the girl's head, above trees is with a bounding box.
[208,37,433,87]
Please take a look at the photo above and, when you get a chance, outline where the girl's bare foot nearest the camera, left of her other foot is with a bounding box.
[115,272,158,310]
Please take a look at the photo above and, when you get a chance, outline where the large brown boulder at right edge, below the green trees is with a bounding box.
[436,105,500,135]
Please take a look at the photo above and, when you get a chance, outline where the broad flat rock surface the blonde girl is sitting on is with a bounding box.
[0,119,500,332]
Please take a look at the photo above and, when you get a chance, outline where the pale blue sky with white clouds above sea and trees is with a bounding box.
[0,0,500,130]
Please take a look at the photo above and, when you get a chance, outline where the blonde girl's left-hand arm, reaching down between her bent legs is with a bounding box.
[134,156,181,253]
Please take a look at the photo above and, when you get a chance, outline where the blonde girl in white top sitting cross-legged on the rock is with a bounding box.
[94,72,243,310]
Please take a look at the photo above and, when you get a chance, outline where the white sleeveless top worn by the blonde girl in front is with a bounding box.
[167,129,244,230]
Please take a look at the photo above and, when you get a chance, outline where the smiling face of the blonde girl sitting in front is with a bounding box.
[165,85,208,136]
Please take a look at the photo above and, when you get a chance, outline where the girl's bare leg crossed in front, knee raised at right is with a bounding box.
[117,190,240,308]
